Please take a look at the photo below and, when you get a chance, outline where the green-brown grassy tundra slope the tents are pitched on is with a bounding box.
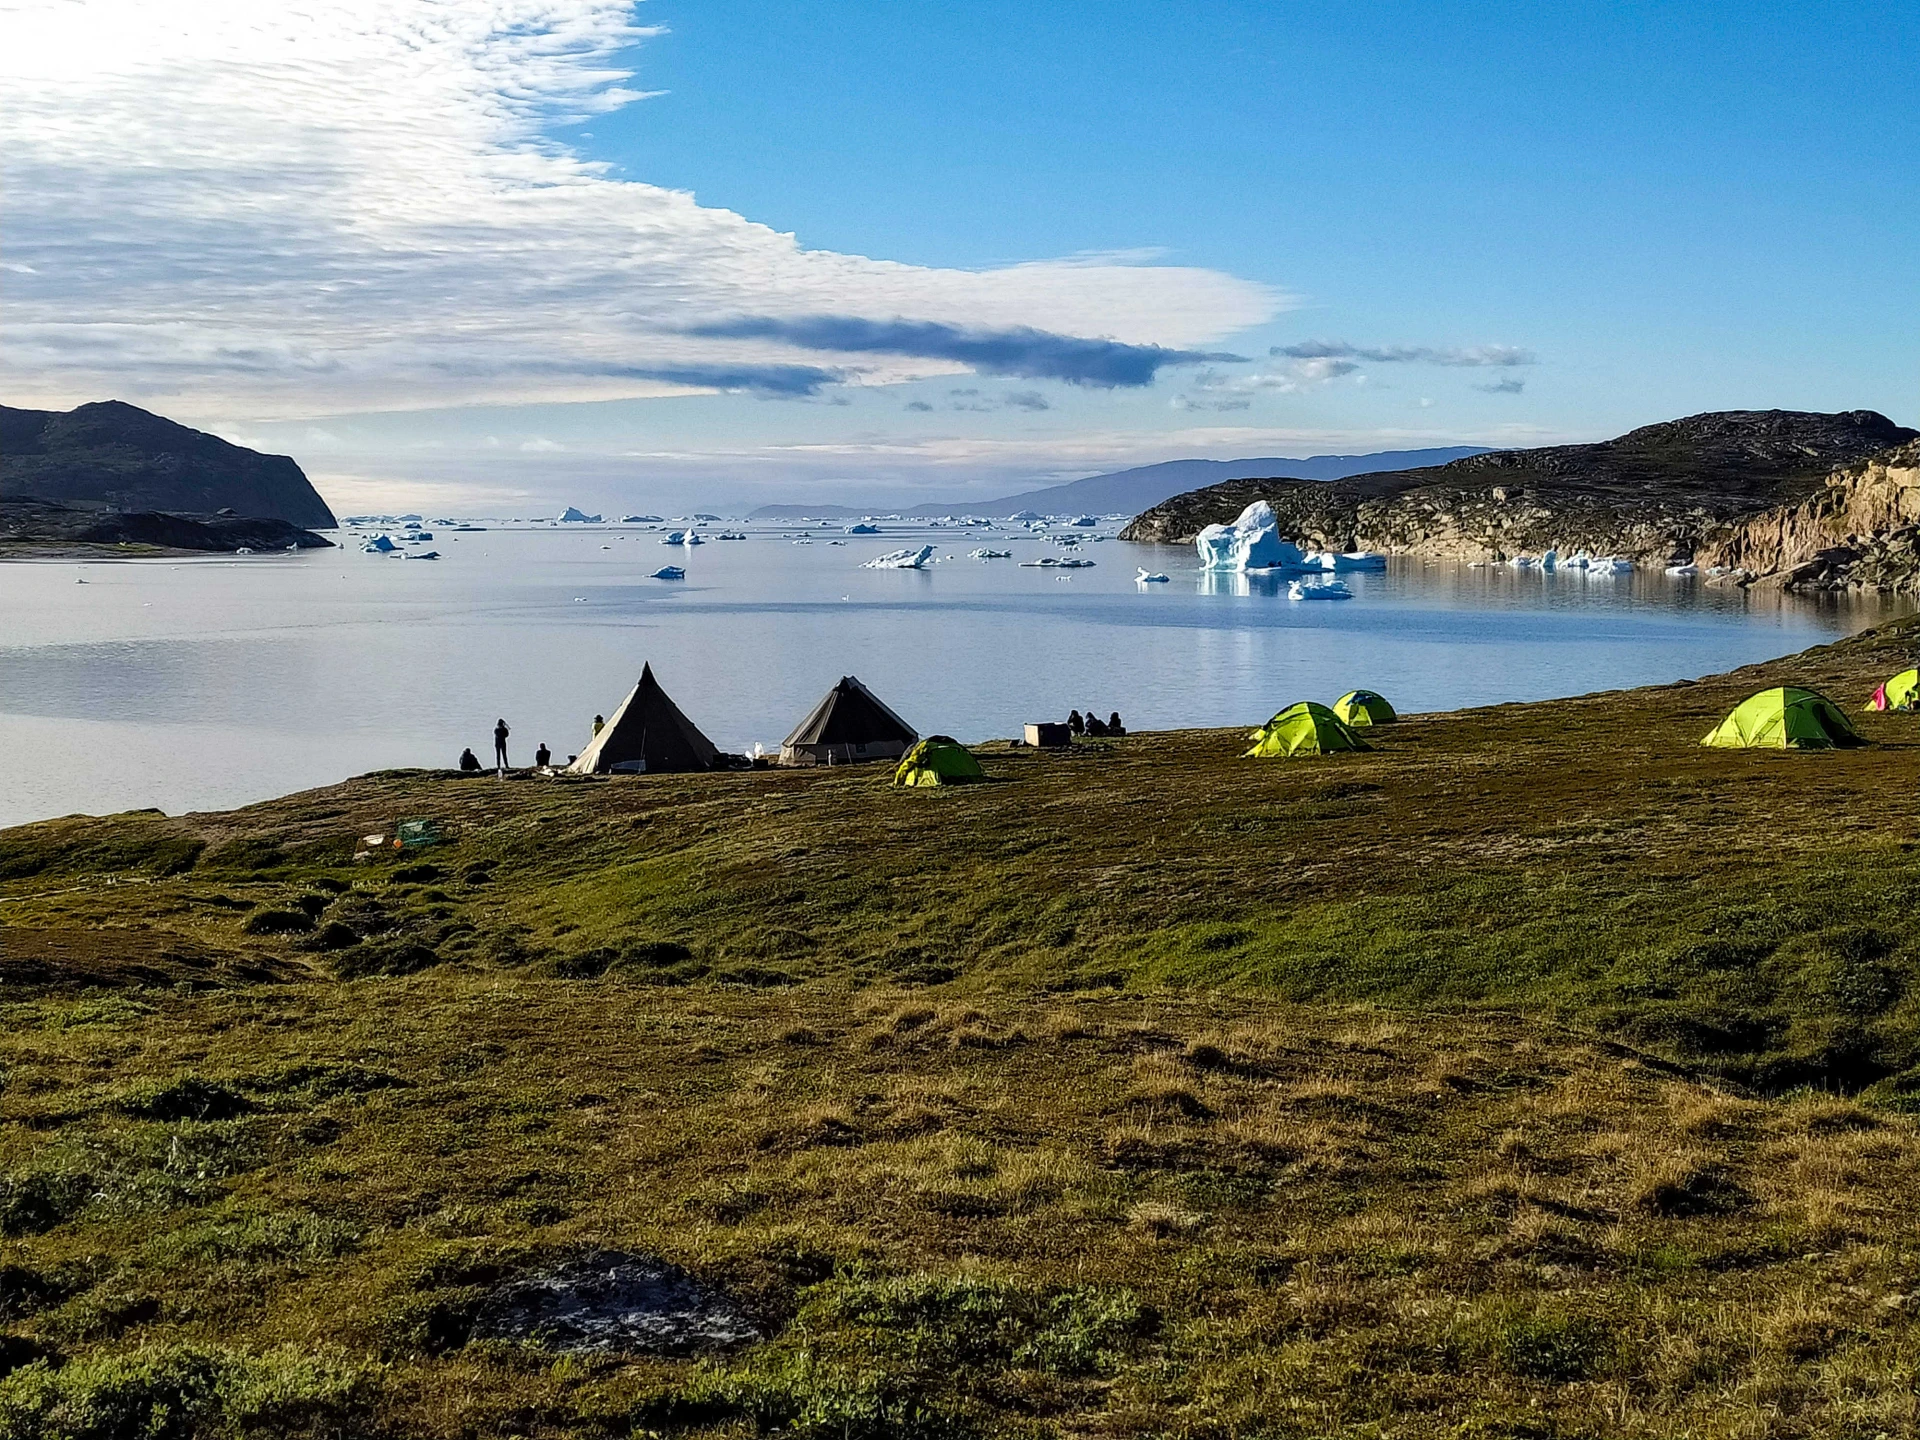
[0,626,1920,1440]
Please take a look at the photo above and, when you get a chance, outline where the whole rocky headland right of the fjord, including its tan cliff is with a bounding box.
[1121,411,1920,589]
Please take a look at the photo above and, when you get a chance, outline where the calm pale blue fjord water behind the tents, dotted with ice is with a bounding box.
[0,524,1893,826]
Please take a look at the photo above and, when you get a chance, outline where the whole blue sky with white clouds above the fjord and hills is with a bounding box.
[0,0,1920,505]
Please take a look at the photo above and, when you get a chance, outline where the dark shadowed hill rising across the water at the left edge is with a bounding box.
[0,399,336,530]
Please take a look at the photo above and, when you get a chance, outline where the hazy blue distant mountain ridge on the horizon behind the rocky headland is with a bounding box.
[747,445,1486,520]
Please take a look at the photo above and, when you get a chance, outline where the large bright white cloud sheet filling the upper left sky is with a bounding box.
[0,0,1286,417]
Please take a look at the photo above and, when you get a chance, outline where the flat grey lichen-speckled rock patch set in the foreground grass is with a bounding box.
[472,1250,760,1356]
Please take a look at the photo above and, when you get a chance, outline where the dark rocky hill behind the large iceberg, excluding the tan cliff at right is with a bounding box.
[1121,411,1920,568]
